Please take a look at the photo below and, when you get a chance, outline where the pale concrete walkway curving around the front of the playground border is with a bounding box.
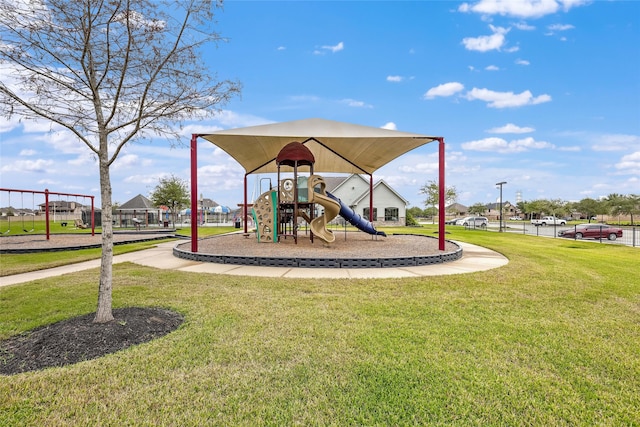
[0,242,509,287]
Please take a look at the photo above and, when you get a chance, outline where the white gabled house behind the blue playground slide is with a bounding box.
[323,174,409,225]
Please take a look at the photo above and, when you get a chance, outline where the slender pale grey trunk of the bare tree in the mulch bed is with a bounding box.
[93,156,113,323]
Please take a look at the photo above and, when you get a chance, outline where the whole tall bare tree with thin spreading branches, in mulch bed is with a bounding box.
[0,0,240,323]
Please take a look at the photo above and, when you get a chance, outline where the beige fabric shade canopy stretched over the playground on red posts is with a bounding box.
[198,119,438,174]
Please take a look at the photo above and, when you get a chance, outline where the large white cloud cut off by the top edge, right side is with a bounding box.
[458,0,589,19]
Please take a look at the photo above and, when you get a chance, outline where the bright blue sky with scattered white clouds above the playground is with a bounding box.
[0,0,640,211]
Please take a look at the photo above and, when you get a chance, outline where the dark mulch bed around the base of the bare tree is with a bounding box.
[0,307,183,375]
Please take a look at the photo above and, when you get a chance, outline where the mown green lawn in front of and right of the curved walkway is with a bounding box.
[0,227,640,426]
